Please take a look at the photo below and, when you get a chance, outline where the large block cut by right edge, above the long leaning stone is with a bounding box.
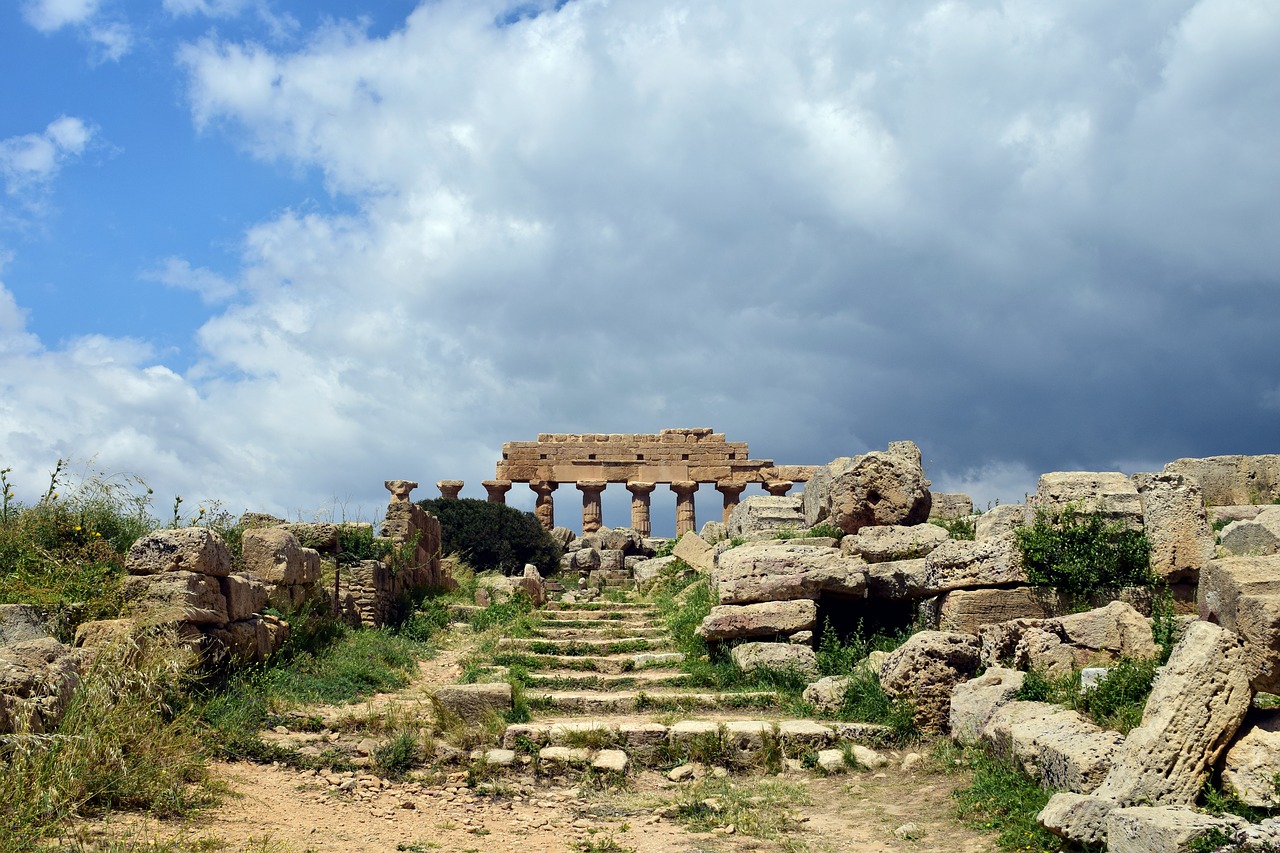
[1197,555,1280,692]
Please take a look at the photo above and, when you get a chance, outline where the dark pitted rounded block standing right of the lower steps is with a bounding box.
[879,631,980,730]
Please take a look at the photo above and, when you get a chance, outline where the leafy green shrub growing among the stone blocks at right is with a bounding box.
[1014,506,1156,598]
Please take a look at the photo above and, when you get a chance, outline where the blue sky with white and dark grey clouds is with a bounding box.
[0,0,1280,533]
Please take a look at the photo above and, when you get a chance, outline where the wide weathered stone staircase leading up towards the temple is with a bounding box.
[486,591,911,776]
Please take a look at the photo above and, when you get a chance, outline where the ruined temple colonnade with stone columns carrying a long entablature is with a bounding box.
[471,428,817,537]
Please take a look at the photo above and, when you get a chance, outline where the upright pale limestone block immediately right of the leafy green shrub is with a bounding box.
[1133,474,1213,583]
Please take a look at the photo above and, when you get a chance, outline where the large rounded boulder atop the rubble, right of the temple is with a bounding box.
[803,442,932,533]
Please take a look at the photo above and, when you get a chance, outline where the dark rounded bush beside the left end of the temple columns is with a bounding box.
[419,498,561,575]
